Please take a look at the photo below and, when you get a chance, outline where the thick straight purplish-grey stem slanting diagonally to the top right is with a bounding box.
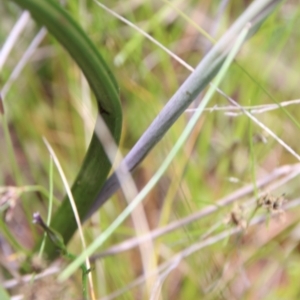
[85,0,282,220]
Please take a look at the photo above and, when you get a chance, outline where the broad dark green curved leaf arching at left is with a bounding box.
[13,0,122,258]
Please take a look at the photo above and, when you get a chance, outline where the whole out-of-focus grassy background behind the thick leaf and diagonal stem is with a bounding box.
[0,0,300,299]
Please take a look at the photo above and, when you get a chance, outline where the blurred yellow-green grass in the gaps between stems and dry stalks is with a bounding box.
[0,1,300,299]
